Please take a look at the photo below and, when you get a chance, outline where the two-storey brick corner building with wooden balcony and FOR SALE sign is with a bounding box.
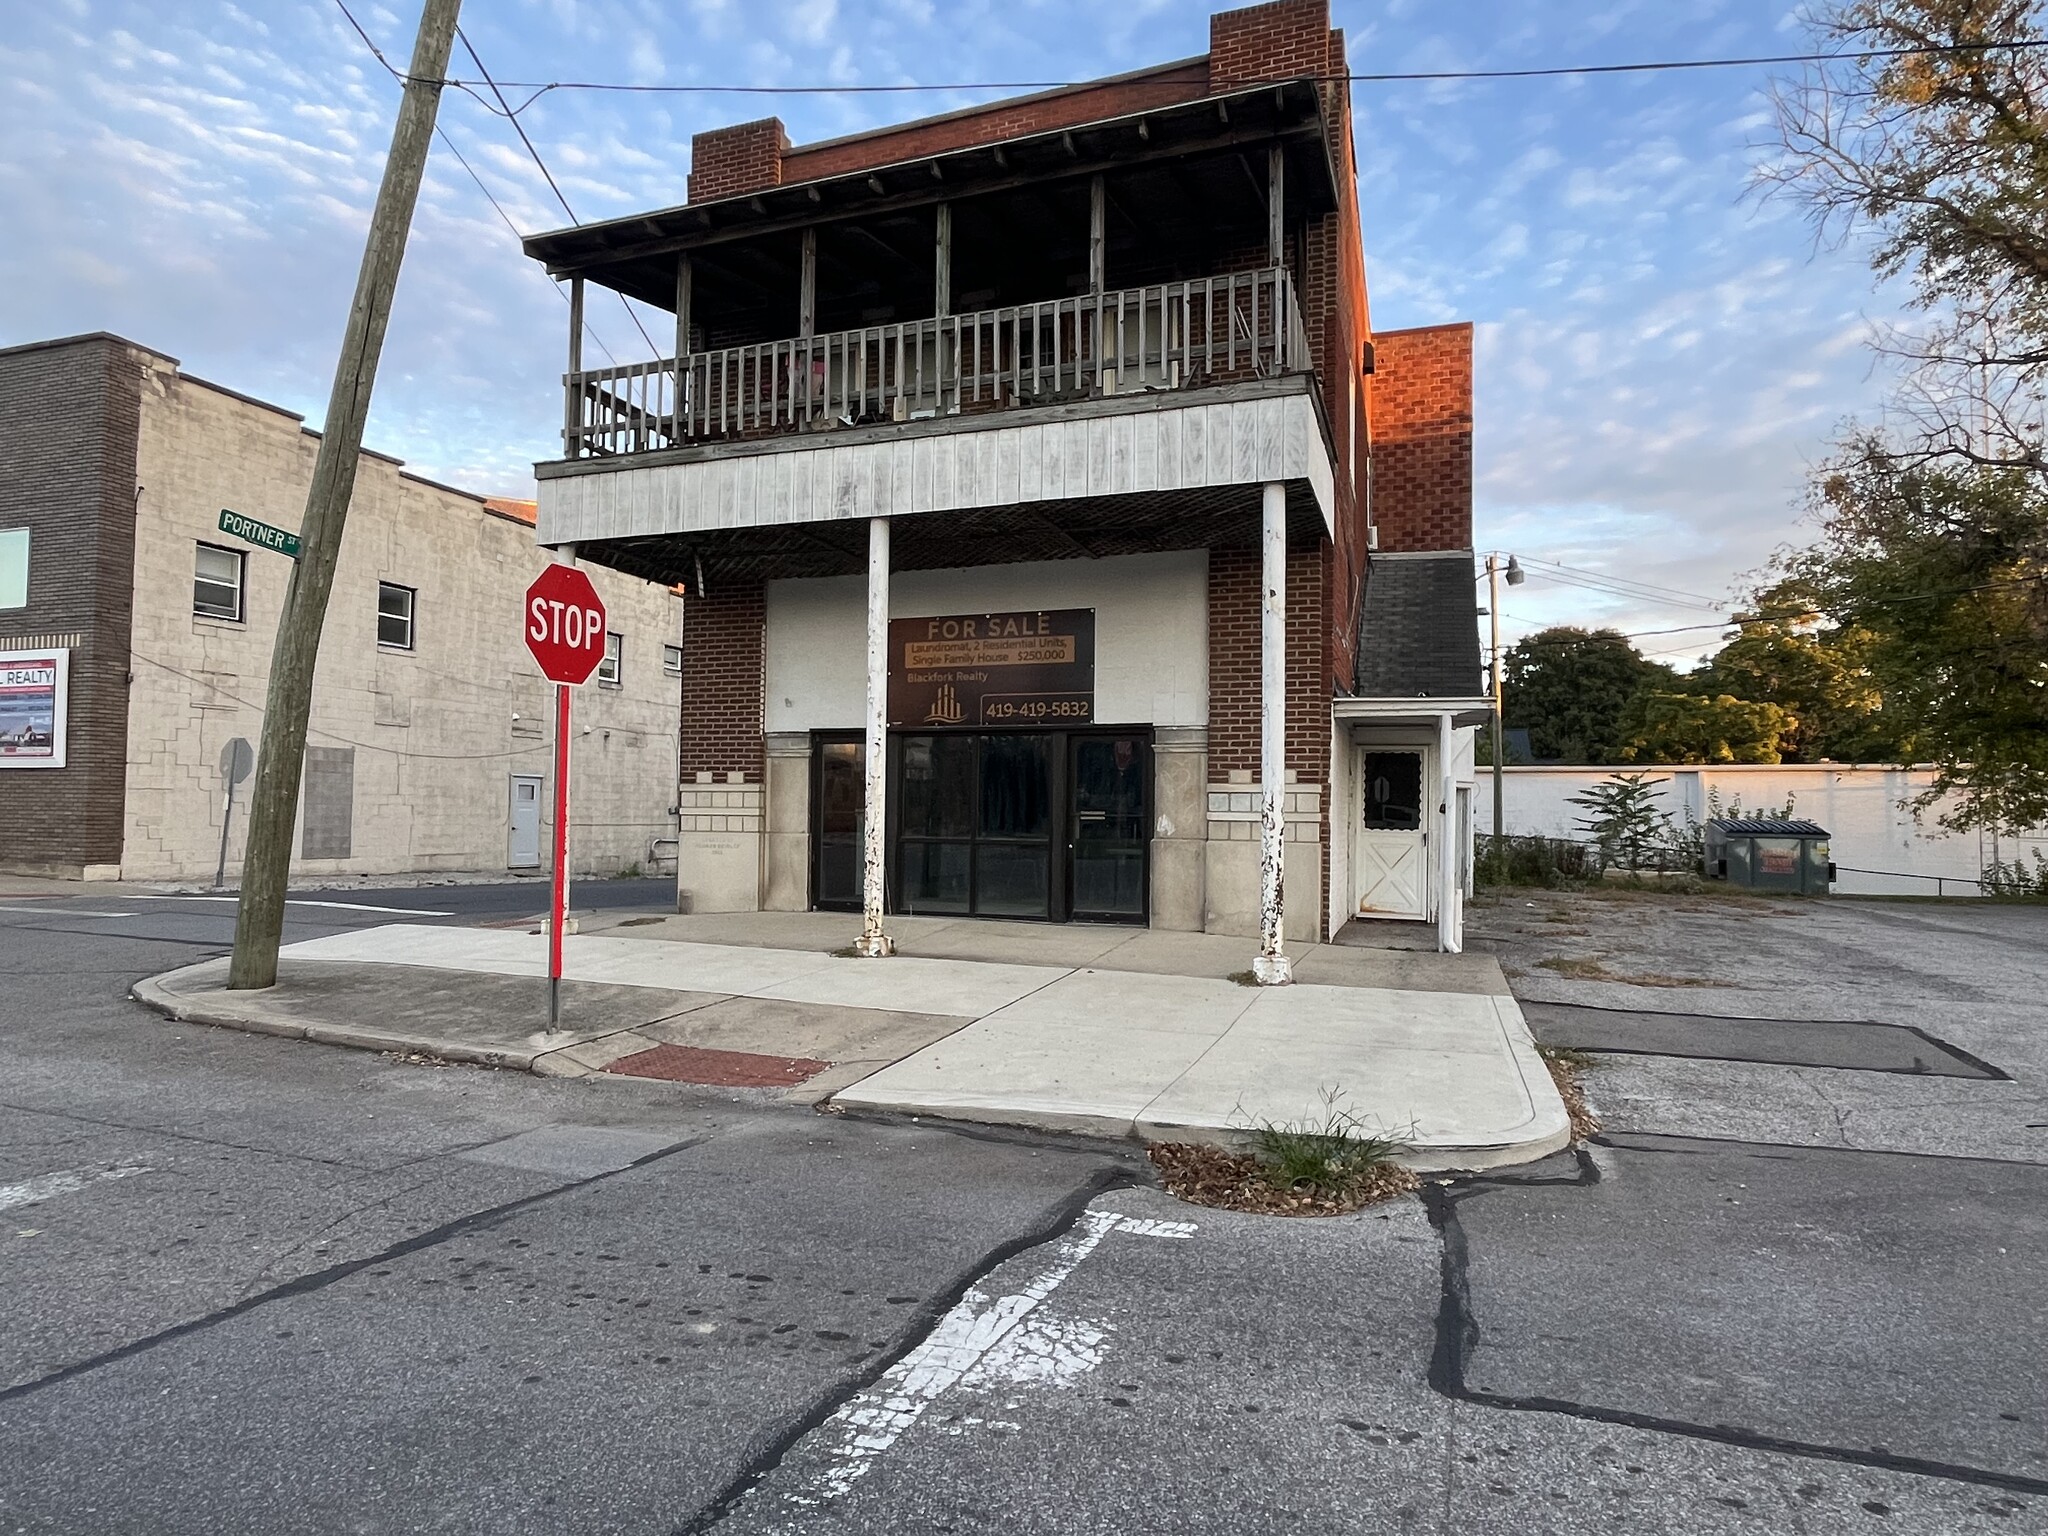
[526,0,1485,962]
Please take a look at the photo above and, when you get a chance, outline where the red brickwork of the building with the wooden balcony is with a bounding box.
[682,0,1473,933]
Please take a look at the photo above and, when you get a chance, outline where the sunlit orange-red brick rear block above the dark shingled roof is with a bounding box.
[1372,324,1473,553]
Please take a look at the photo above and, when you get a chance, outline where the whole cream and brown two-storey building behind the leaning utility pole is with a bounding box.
[0,336,680,881]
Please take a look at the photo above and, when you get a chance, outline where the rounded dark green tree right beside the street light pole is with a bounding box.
[1501,625,1677,762]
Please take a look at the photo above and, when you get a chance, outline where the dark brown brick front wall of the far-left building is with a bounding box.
[0,336,147,877]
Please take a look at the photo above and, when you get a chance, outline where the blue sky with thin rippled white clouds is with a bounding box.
[0,0,1896,662]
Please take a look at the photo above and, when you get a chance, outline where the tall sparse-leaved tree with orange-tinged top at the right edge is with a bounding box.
[1763,0,2048,827]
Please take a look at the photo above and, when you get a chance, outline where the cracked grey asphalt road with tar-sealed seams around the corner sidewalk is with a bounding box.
[0,883,2048,1536]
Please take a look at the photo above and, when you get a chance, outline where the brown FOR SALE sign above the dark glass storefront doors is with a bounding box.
[889,608,1096,731]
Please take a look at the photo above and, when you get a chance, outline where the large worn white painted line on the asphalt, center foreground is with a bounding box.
[761,1210,1194,1507]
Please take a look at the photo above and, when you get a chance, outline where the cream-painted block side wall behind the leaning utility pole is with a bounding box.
[121,360,678,879]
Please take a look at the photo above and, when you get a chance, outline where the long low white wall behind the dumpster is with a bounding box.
[1473,762,2038,895]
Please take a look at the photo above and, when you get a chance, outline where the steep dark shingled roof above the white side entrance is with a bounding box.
[1356,549,1487,698]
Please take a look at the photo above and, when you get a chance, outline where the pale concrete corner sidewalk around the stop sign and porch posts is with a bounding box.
[137,913,1569,1167]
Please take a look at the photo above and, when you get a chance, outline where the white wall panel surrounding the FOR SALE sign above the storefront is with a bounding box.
[764,549,1208,731]
